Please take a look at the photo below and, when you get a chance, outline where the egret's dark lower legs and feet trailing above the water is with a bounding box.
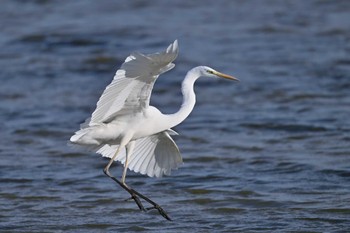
[103,169,171,221]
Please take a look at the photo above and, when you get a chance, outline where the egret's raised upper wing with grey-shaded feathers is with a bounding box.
[87,40,178,126]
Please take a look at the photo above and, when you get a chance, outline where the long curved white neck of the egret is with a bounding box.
[166,68,201,129]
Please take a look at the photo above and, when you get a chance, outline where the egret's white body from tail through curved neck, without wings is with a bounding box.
[70,66,208,145]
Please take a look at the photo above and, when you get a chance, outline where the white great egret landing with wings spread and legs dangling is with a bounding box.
[70,40,237,220]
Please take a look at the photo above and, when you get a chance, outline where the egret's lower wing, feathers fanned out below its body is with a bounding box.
[97,130,182,177]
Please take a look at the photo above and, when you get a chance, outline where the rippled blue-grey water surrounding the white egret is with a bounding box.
[0,0,350,232]
